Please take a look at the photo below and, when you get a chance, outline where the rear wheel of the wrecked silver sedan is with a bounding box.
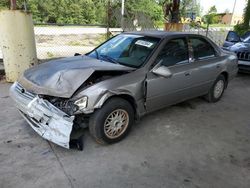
[205,75,227,103]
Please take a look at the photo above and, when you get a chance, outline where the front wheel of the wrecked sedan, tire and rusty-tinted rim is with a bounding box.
[89,98,134,144]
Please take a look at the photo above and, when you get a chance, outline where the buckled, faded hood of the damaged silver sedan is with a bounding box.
[18,56,133,98]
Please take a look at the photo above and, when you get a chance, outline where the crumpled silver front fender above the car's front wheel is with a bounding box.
[72,69,145,114]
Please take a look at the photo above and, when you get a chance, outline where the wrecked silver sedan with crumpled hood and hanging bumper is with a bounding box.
[10,31,238,148]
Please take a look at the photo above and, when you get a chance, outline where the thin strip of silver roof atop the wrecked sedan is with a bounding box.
[124,30,202,38]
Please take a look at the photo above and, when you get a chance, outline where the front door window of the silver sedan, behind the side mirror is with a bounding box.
[157,38,188,67]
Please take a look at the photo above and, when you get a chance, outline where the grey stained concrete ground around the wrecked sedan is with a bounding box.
[0,75,250,188]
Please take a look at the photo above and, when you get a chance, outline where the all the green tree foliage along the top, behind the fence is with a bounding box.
[0,0,200,26]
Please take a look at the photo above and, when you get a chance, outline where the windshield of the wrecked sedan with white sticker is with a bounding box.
[88,34,160,68]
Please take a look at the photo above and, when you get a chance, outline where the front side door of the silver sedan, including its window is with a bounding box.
[146,38,195,112]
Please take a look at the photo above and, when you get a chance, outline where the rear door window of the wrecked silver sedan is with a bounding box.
[190,38,215,60]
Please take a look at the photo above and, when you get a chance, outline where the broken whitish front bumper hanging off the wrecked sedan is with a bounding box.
[10,82,74,149]
